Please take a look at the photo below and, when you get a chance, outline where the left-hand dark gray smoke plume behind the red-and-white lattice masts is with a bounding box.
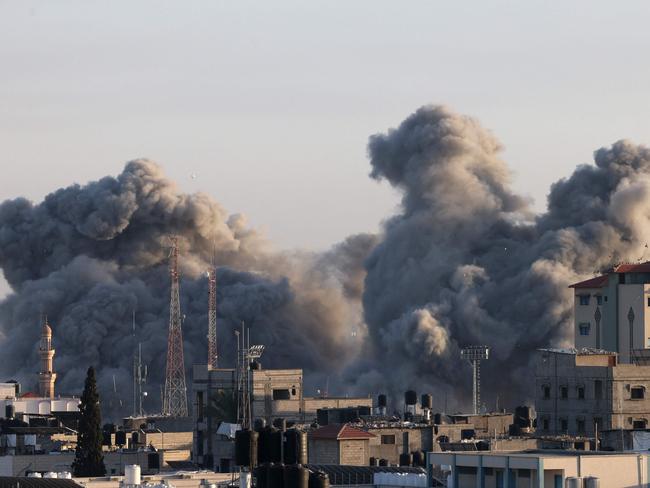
[0,160,374,415]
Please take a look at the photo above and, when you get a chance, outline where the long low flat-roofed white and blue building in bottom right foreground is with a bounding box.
[427,450,650,488]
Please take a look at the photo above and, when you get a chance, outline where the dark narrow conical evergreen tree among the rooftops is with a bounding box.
[72,366,106,477]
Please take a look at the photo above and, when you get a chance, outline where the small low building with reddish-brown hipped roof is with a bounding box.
[309,424,375,466]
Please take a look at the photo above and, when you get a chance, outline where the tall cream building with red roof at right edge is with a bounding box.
[570,262,650,363]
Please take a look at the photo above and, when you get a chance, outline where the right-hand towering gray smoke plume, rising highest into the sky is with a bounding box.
[363,107,650,412]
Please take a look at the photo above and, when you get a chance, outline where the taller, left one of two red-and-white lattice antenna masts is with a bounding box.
[162,236,188,417]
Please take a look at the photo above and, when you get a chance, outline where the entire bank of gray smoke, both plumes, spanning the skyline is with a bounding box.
[0,107,650,415]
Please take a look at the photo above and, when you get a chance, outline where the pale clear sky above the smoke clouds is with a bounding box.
[0,0,650,294]
